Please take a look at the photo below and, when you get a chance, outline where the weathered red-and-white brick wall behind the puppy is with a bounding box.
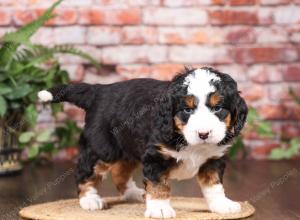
[0,0,300,158]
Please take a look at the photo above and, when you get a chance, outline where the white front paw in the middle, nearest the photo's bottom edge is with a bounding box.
[145,200,176,219]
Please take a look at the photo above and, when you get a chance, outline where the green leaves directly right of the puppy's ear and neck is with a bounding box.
[228,108,274,159]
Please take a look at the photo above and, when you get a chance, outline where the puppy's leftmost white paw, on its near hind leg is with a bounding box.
[79,194,106,211]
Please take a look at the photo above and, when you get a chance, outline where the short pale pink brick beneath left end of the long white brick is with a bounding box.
[122,26,157,44]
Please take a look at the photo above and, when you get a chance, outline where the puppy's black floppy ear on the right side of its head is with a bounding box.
[233,94,248,136]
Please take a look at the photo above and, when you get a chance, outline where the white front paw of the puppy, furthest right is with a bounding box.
[208,197,241,214]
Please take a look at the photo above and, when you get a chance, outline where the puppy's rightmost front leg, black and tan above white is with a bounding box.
[198,159,241,214]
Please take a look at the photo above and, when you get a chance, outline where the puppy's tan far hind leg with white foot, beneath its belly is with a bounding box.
[111,161,145,202]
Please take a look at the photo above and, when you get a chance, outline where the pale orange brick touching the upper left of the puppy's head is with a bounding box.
[151,63,184,80]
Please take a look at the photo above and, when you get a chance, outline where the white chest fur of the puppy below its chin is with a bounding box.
[163,145,228,180]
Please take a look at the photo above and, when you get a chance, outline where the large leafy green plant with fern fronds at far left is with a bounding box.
[0,0,99,158]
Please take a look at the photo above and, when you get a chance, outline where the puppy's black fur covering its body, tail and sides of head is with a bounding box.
[43,68,247,186]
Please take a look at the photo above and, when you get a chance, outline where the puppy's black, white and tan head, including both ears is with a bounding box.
[158,68,248,145]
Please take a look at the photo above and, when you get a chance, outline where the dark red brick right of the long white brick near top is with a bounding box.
[209,10,258,25]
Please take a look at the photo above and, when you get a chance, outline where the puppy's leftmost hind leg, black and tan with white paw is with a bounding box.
[76,150,109,211]
